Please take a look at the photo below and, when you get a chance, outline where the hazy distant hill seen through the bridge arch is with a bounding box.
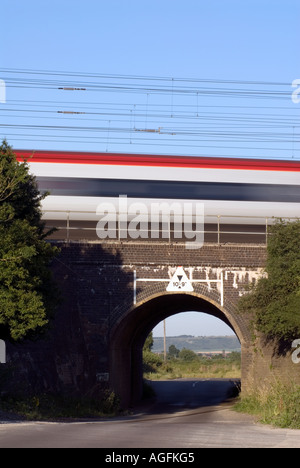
[152,335,241,353]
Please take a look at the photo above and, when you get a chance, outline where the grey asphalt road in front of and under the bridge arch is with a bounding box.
[0,381,300,450]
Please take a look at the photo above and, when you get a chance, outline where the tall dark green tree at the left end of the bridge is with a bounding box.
[0,141,58,340]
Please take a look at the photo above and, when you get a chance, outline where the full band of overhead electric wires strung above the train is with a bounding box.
[0,68,300,157]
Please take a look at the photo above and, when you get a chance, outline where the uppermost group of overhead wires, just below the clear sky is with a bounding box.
[0,68,296,98]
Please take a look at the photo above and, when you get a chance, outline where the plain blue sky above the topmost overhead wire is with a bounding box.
[1,0,300,82]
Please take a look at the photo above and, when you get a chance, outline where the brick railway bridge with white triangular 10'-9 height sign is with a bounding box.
[7,236,300,407]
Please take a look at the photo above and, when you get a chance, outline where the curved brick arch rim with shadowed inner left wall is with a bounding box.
[109,290,250,406]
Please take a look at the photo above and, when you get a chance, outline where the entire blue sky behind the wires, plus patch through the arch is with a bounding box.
[0,0,300,335]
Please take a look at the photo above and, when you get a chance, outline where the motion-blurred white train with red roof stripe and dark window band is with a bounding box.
[15,150,300,224]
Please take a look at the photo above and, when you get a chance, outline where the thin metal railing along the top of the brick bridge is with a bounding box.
[43,210,298,245]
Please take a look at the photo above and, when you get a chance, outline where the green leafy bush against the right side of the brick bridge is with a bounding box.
[239,220,300,343]
